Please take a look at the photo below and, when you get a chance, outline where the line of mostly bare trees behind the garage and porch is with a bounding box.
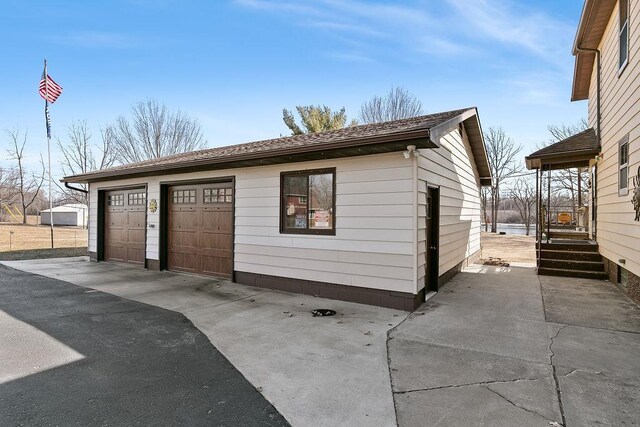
[0,87,586,234]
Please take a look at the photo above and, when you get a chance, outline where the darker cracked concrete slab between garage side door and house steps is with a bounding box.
[388,266,640,427]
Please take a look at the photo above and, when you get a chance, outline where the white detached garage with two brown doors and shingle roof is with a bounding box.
[63,108,491,310]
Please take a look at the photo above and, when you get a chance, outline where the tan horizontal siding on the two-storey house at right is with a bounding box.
[589,1,640,276]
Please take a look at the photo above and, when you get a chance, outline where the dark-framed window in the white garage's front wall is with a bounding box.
[280,169,336,235]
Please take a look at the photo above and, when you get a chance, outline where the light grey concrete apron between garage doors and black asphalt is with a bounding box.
[3,257,408,426]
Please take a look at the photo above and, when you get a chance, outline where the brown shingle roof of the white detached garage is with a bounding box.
[62,108,478,182]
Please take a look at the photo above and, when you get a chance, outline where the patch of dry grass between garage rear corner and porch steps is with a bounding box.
[480,232,536,264]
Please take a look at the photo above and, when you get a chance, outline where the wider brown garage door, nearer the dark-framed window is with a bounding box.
[167,182,233,277]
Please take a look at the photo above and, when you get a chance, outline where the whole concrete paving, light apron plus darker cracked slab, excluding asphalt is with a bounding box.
[5,258,640,426]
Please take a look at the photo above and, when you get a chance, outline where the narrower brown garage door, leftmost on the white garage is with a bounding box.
[104,188,147,265]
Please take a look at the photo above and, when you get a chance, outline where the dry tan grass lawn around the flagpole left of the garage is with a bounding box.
[0,223,87,252]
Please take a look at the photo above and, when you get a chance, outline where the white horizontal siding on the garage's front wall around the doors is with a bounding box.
[89,153,416,293]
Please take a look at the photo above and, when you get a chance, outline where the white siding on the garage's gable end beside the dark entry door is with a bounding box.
[417,128,480,289]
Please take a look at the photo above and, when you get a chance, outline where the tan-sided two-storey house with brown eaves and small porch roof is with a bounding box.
[527,0,640,303]
